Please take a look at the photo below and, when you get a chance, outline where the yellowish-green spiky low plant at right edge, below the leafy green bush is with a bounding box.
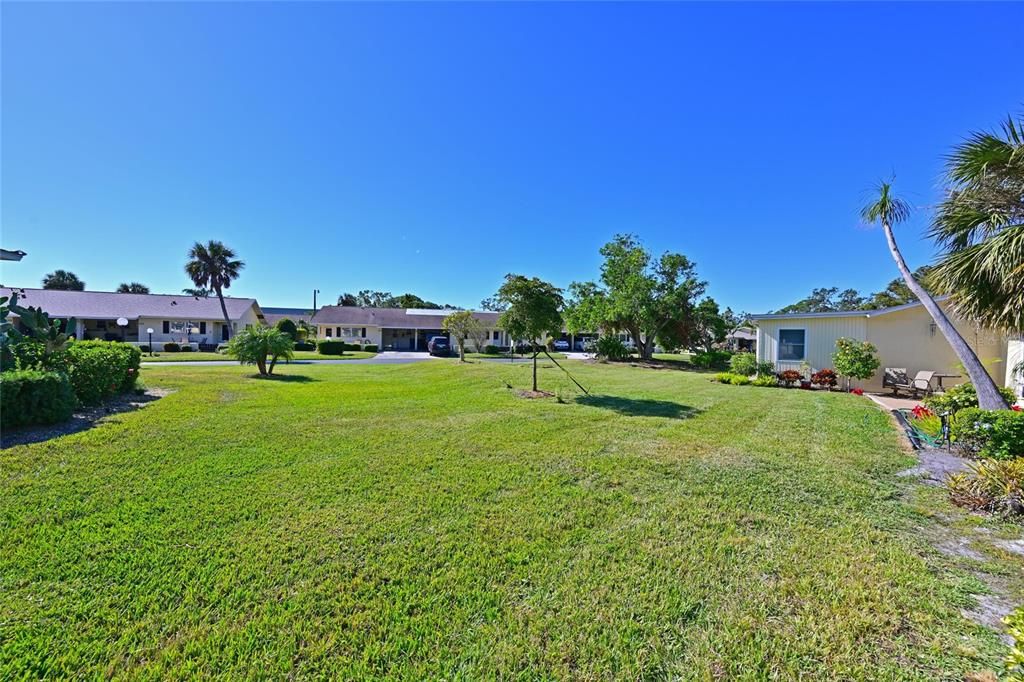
[946,457,1024,515]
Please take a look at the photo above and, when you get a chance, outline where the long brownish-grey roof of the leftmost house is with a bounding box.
[0,287,263,319]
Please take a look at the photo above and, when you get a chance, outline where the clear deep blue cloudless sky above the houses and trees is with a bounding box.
[0,2,1024,311]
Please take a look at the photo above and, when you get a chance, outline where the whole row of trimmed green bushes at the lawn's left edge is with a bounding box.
[0,340,142,427]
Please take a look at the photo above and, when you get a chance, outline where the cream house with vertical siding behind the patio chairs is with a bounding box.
[751,299,1024,395]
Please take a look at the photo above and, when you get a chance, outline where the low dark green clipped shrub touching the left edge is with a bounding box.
[0,370,75,429]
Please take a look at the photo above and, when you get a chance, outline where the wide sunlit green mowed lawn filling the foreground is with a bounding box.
[0,363,1001,680]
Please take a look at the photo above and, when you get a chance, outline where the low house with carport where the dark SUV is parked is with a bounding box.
[313,305,510,350]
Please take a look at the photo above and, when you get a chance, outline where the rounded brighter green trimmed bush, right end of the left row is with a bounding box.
[68,341,142,404]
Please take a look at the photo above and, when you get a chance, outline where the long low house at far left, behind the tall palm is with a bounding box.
[0,287,265,350]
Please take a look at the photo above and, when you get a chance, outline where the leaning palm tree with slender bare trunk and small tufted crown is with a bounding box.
[860,182,1009,410]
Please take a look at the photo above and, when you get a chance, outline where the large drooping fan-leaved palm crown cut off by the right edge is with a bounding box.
[930,117,1024,333]
